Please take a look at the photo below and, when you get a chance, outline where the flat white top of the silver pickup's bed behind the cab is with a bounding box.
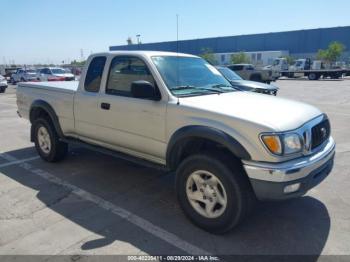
[18,81,79,94]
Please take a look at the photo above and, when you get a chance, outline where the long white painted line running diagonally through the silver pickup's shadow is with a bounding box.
[0,153,211,255]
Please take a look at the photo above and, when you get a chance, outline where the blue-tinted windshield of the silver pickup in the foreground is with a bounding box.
[152,56,235,96]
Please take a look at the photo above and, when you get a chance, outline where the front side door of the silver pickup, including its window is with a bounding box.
[97,56,166,163]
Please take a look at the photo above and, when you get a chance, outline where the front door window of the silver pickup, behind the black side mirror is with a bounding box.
[106,56,155,97]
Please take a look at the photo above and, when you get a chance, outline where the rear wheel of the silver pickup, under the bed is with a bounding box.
[33,118,68,162]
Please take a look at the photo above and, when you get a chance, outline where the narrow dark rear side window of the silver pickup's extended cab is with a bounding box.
[84,56,106,92]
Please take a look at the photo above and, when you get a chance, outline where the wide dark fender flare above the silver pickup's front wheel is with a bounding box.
[166,126,251,169]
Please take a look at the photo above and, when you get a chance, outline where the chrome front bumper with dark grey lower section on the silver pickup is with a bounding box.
[243,137,335,200]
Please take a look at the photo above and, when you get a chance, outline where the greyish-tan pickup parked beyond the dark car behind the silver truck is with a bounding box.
[227,64,277,84]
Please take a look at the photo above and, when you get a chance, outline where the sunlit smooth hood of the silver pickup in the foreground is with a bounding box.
[179,91,322,132]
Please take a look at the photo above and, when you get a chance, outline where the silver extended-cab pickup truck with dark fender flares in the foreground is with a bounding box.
[17,51,335,233]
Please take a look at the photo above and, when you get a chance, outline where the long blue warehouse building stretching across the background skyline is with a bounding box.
[109,26,350,55]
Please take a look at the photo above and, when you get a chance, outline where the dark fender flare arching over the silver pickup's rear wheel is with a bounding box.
[29,100,64,142]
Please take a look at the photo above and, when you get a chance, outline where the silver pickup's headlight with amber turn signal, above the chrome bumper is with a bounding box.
[261,133,302,155]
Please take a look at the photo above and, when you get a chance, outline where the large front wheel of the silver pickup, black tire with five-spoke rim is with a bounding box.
[176,154,256,234]
